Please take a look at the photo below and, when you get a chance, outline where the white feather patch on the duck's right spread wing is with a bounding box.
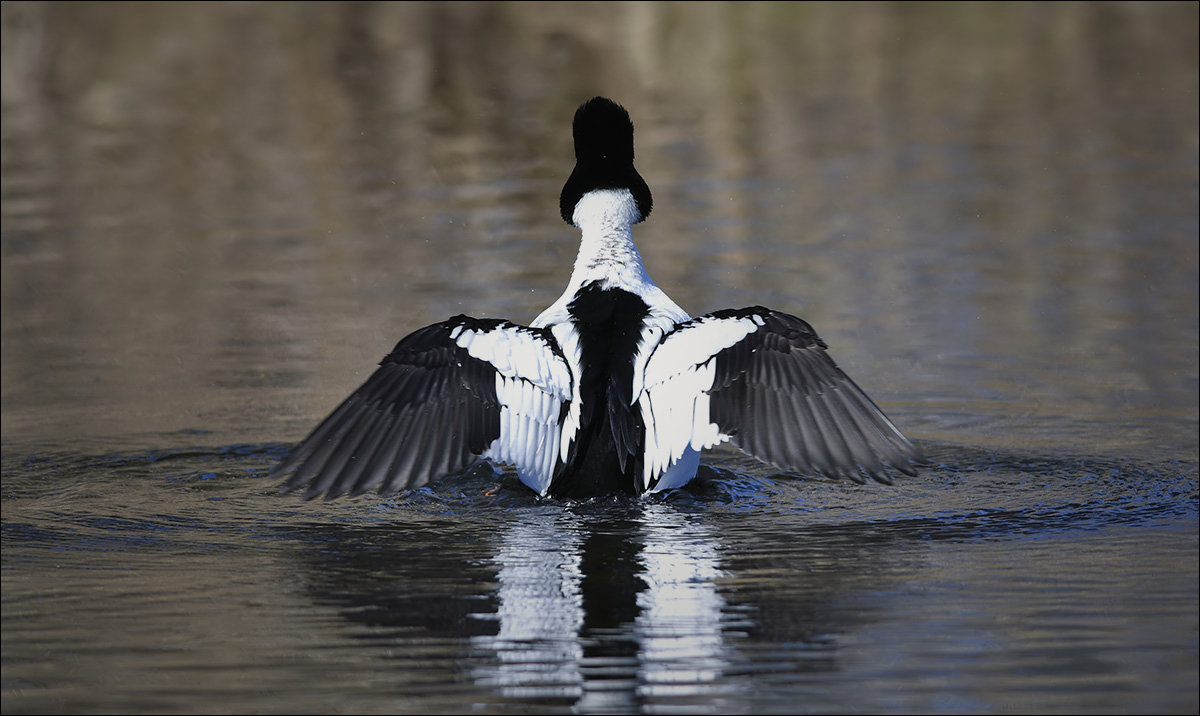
[636,315,763,489]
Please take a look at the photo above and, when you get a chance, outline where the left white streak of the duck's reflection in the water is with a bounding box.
[473,513,583,697]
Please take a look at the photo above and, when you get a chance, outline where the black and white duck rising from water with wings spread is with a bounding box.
[270,97,924,499]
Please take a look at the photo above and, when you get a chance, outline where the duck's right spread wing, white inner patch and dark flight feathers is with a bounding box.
[638,306,924,488]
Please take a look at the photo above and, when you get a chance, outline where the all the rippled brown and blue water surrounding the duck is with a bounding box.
[0,2,1200,714]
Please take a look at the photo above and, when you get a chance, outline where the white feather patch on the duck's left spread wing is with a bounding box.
[450,324,578,494]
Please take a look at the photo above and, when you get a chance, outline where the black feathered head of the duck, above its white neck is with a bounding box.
[558,97,653,224]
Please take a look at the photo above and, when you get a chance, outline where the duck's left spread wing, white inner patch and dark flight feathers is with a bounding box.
[272,315,571,499]
